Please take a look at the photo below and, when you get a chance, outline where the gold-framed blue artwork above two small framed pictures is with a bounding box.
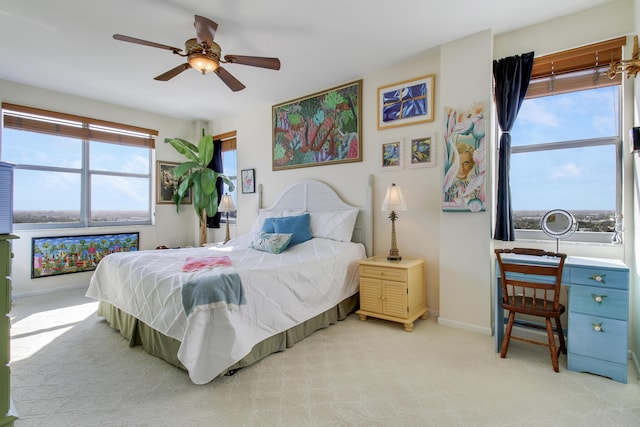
[378,74,435,130]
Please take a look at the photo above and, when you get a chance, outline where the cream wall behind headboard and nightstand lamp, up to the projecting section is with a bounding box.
[212,50,442,313]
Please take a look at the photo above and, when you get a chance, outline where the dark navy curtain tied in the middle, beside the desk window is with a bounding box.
[493,52,533,241]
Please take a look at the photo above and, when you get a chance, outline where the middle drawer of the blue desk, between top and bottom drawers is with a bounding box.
[569,285,629,320]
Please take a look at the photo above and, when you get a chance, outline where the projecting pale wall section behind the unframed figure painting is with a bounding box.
[438,30,493,335]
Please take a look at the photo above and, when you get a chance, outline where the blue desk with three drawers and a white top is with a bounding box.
[494,254,629,383]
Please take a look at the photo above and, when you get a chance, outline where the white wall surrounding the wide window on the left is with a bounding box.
[0,80,197,297]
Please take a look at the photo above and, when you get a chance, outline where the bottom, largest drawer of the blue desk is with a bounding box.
[568,313,627,363]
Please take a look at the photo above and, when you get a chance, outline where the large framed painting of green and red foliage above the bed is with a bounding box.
[272,80,362,171]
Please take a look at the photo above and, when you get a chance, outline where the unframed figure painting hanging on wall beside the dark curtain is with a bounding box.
[442,103,486,212]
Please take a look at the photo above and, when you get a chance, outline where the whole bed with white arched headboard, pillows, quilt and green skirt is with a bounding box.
[86,177,373,384]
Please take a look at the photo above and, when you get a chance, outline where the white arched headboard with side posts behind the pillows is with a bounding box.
[258,175,373,256]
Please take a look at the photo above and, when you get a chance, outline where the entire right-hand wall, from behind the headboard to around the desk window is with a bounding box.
[211,0,632,333]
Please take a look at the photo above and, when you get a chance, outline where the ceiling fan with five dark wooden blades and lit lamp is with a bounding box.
[113,15,280,92]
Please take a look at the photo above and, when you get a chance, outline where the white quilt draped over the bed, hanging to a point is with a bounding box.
[87,234,365,384]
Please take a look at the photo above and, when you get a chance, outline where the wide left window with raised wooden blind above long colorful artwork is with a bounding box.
[0,103,158,229]
